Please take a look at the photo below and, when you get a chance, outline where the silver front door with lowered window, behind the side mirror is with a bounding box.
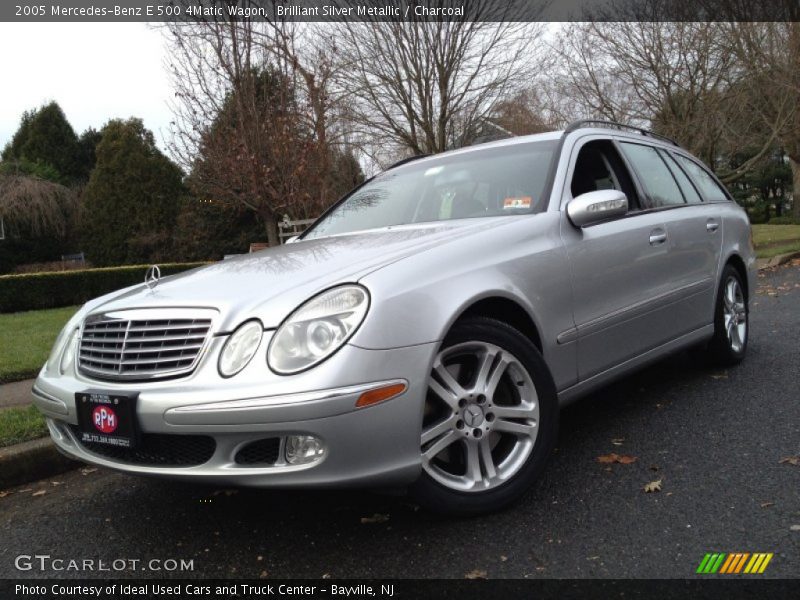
[561,139,674,381]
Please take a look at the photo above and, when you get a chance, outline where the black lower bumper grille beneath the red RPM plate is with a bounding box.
[70,425,217,467]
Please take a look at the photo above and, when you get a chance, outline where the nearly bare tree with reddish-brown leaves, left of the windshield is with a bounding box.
[166,10,350,244]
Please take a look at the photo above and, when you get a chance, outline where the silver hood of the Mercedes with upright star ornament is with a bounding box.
[89,217,508,331]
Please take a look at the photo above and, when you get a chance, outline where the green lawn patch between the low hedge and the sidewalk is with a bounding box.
[0,306,78,383]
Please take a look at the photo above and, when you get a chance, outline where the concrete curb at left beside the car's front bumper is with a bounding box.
[0,438,82,489]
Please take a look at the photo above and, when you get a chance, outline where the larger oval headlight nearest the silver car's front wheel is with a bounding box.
[267,285,369,375]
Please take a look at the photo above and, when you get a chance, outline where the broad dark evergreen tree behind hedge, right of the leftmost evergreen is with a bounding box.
[82,119,184,265]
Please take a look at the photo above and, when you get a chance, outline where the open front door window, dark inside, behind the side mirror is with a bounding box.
[570,140,637,209]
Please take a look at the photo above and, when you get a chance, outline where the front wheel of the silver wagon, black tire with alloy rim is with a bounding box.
[410,317,558,516]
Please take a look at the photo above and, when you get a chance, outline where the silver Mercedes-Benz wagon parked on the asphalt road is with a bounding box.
[33,121,755,514]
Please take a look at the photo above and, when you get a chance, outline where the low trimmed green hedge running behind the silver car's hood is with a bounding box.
[0,262,208,313]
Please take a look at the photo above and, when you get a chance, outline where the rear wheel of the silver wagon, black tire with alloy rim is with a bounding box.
[708,264,750,366]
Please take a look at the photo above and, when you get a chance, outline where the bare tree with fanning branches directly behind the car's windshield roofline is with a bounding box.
[339,1,543,162]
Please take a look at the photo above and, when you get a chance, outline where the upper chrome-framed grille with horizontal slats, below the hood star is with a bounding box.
[78,309,212,380]
